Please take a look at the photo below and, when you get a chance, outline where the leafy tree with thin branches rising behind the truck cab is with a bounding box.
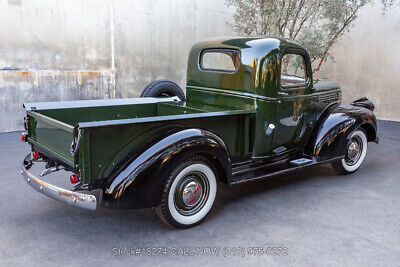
[225,0,396,72]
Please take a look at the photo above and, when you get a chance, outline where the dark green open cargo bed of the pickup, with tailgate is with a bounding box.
[24,98,255,182]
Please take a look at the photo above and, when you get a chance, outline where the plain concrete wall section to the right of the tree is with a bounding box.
[318,2,400,121]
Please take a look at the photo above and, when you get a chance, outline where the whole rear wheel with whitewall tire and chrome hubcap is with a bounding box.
[156,156,217,228]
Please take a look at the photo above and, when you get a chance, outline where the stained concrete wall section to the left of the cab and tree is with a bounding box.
[0,0,233,132]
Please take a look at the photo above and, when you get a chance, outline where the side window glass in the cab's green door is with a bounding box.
[281,54,307,87]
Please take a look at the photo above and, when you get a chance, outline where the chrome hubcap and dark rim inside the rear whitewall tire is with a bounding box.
[174,172,210,216]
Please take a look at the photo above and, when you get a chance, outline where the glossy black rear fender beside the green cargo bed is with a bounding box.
[102,129,232,208]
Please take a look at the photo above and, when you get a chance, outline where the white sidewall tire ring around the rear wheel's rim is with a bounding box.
[165,160,217,227]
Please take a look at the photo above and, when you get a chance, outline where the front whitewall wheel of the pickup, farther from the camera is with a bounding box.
[332,129,368,174]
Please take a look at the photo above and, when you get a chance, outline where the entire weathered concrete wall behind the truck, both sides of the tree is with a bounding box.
[0,0,400,132]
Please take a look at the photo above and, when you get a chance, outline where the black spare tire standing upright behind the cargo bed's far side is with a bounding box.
[140,80,185,101]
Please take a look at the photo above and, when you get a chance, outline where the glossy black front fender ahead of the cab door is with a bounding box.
[305,106,377,160]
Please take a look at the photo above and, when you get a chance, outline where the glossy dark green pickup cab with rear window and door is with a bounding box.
[186,38,341,161]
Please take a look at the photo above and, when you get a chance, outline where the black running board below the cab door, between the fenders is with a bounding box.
[231,157,343,185]
